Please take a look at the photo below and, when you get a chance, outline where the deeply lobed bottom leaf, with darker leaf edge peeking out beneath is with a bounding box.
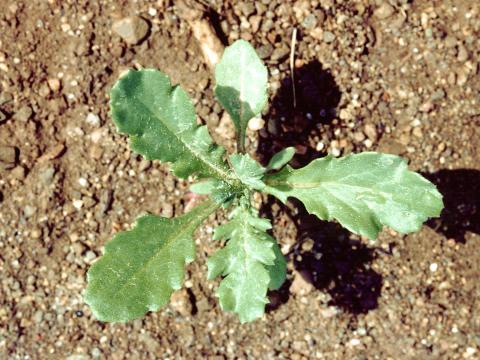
[208,207,286,323]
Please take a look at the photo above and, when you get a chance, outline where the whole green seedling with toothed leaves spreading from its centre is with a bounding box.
[85,40,443,323]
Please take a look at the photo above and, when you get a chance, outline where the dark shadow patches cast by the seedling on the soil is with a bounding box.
[257,61,480,315]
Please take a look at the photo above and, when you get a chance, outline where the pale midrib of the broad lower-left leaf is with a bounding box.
[112,200,220,296]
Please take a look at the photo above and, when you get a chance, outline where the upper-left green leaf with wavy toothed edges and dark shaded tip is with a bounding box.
[110,69,234,180]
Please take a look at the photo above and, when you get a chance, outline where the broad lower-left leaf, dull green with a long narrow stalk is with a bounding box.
[85,201,218,322]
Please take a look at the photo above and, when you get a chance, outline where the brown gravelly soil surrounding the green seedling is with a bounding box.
[0,0,480,360]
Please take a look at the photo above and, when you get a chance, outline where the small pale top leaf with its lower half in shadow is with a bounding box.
[215,40,268,152]
